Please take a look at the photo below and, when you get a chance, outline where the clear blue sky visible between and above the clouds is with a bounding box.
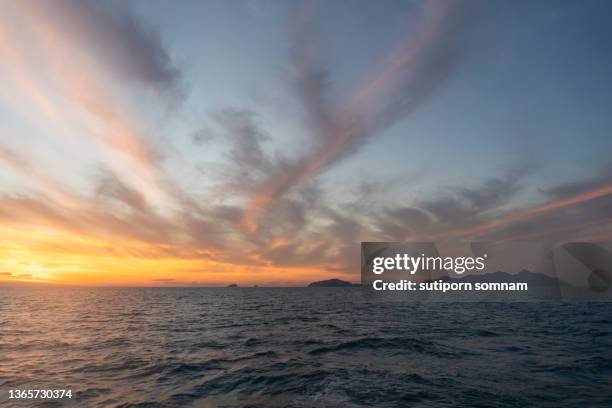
[134,2,612,202]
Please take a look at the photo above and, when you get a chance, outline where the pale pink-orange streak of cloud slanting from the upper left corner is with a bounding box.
[0,0,159,192]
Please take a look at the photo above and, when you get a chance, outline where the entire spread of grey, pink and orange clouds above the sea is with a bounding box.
[0,0,612,284]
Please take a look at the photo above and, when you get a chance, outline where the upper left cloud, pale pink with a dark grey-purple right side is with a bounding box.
[0,0,181,188]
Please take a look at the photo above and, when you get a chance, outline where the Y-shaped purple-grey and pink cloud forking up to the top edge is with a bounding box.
[241,1,474,217]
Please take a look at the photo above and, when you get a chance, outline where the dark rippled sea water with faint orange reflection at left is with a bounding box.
[0,288,612,407]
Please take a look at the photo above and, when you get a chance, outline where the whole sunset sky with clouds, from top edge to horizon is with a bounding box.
[0,0,612,286]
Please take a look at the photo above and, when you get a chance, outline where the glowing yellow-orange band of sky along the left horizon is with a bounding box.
[0,226,328,286]
